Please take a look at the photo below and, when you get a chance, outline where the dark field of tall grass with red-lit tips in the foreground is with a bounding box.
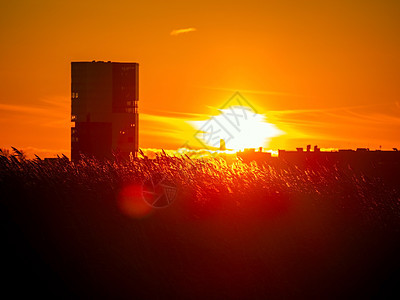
[0,157,400,299]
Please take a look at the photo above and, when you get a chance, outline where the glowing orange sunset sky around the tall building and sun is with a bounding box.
[0,0,400,155]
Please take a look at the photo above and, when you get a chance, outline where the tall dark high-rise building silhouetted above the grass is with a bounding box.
[71,61,139,161]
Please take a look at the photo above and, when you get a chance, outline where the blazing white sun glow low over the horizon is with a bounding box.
[192,106,283,150]
